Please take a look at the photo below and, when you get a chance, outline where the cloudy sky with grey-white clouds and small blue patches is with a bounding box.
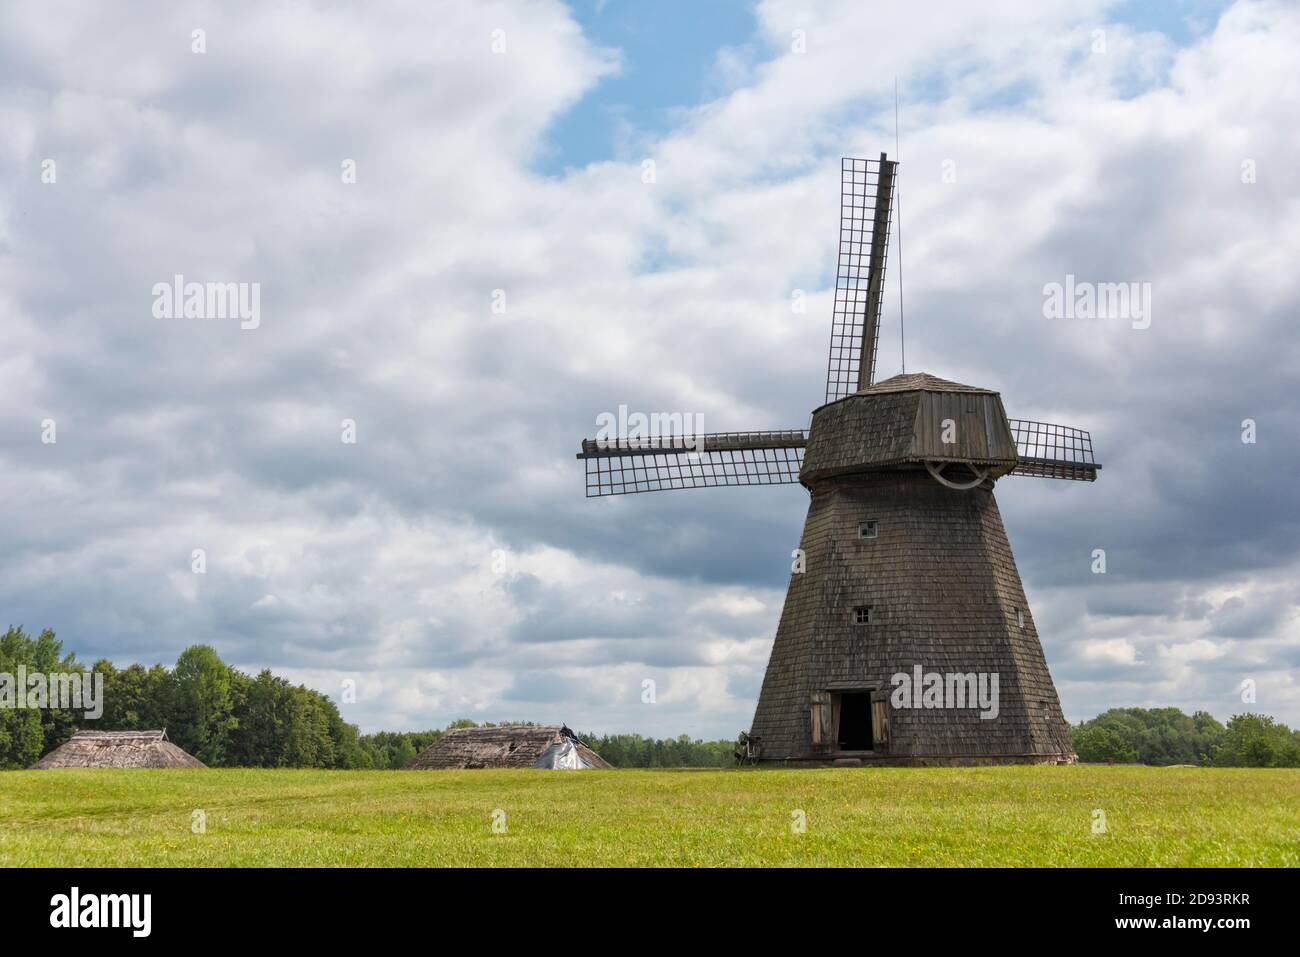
[0,0,1300,737]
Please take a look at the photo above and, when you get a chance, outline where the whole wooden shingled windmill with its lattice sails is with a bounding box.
[577,153,1101,765]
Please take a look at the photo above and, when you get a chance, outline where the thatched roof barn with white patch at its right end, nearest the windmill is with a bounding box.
[407,724,612,771]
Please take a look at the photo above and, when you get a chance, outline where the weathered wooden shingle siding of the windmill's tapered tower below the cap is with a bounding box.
[750,468,1074,763]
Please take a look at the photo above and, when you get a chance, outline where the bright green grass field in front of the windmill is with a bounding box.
[0,767,1300,866]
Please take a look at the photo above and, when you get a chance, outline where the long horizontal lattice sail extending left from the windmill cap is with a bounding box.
[577,429,809,498]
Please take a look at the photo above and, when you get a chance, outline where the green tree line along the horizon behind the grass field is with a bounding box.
[0,628,1300,768]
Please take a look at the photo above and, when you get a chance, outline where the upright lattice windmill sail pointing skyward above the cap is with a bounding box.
[826,153,898,402]
